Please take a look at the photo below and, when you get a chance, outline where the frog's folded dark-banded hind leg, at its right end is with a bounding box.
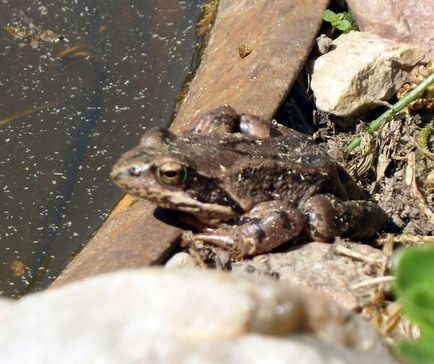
[302,194,390,241]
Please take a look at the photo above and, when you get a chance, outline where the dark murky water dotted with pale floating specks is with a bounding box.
[0,0,202,296]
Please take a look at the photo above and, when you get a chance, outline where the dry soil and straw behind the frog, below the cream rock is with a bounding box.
[276,68,434,241]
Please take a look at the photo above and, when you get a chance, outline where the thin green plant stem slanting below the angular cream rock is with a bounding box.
[347,73,434,152]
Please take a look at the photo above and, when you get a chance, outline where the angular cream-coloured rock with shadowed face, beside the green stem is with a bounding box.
[311,32,424,117]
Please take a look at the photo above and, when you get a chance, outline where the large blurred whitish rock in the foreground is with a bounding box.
[0,268,397,364]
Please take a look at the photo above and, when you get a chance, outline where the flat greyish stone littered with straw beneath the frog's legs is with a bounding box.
[232,242,386,310]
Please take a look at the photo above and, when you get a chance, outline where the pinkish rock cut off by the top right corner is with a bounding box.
[348,0,434,60]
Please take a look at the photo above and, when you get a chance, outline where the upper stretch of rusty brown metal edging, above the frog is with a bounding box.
[172,0,328,132]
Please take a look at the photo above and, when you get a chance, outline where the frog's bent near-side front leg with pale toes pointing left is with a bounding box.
[192,201,307,256]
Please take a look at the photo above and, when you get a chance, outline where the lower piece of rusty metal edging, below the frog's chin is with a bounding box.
[51,200,182,287]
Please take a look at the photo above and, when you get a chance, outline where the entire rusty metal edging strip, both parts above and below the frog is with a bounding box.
[52,0,328,287]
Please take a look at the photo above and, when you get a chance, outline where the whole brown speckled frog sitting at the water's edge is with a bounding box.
[112,106,389,255]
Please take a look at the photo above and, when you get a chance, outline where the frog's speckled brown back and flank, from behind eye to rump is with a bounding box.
[171,130,361,205]
